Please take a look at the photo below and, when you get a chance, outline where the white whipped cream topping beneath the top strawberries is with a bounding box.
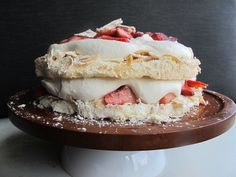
[48,34,194,61]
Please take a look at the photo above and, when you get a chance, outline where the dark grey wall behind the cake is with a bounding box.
[0,0,236,117]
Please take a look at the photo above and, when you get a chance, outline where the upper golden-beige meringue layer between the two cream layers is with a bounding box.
[35,51,200,80]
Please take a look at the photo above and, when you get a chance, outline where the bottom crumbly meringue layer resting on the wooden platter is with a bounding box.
[36,89,203,123]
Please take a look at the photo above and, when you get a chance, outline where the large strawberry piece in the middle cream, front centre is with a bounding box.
[104,86,137,105]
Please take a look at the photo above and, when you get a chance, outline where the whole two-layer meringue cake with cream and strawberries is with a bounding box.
[35,19,207,123]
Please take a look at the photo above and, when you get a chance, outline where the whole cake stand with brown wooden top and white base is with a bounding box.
[8,88,236,177]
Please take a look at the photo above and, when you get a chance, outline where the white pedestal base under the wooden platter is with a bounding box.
[62,146,166,177]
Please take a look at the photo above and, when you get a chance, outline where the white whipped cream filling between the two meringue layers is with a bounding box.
[42,78,184,104]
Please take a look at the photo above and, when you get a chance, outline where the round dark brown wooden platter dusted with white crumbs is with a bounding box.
[8,88,236,151]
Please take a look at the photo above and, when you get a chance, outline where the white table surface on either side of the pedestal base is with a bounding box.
[0,119,236,177]
